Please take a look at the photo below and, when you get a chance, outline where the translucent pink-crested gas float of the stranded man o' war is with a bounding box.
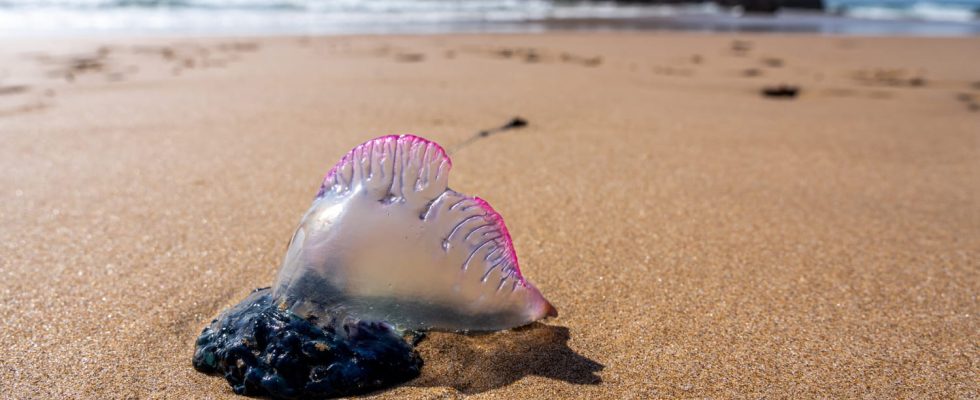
[273,135,557,331]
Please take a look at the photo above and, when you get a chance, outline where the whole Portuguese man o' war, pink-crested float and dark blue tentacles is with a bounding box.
[194,135,557,398]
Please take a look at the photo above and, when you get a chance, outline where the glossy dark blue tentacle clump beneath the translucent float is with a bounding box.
[193,289,422,399]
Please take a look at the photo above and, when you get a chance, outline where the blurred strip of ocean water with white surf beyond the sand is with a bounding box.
[0,0,980,37]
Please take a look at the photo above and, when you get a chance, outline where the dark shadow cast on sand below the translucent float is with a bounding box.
[409,323,605,394]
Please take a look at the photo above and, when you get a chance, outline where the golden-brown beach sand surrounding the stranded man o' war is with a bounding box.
[0,33,980,399]
